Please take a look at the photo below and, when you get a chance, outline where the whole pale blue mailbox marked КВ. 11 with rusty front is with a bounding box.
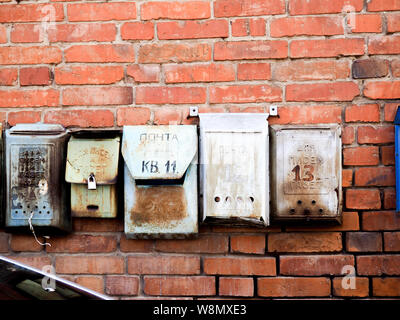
[122,125,198,238]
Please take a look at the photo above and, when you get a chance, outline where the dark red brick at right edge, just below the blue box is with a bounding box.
[361,211,400,231]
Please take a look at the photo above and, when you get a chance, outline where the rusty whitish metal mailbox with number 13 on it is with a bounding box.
[270,125,342,222]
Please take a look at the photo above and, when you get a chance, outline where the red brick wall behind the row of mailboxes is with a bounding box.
[0,0,400,299]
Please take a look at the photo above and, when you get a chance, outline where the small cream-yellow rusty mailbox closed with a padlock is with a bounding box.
[65,132,120,218]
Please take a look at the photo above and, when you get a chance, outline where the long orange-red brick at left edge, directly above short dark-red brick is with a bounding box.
[0,46,62,64]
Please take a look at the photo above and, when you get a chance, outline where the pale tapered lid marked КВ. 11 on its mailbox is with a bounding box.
[121,125,197,180]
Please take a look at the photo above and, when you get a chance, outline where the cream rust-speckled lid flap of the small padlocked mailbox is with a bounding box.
[65,136,120,184]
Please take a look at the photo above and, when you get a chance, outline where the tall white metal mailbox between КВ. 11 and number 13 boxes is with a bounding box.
[200,113,269,226]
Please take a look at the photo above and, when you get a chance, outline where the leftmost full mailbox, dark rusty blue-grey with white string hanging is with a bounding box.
[5,123,71,232]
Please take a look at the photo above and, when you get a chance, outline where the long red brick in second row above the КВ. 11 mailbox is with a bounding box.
[136,87,206,104]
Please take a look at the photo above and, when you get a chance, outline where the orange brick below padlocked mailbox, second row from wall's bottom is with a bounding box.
[55,256,124,274]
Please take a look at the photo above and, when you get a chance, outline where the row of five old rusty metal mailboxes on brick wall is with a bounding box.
[3,114,341,238]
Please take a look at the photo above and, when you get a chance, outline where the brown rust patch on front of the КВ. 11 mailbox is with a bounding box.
[131,186,187,226]
